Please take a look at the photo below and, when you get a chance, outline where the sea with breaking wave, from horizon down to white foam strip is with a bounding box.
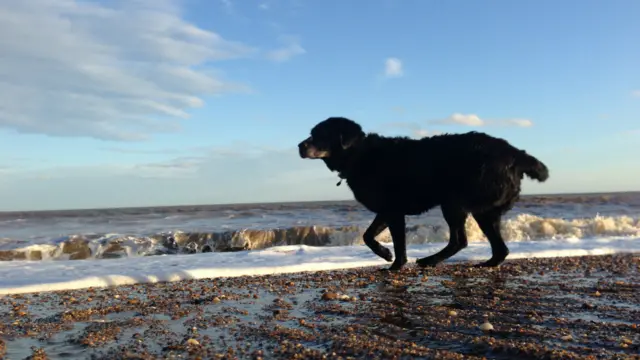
[0,192,640,262]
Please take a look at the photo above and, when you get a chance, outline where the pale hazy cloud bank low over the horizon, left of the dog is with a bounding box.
[0,148,352,211]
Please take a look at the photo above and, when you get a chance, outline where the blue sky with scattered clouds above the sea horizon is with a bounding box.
[0,0,640,211]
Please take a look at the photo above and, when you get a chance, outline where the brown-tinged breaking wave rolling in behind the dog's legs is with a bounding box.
[0,214,640,261]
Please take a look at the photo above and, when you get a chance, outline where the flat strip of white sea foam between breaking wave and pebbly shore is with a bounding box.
[0,236,640,294]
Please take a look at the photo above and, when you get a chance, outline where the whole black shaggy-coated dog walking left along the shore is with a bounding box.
[298,117,549,270]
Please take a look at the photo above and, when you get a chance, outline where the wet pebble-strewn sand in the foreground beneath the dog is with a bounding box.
[0,254,640,359]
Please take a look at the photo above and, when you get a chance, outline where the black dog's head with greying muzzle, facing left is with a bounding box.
[298,117,365,159]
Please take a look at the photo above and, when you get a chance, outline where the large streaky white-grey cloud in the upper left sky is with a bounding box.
[0,0,256,140]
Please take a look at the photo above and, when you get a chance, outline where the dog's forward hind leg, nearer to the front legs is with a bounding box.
[416,206,468,267]
